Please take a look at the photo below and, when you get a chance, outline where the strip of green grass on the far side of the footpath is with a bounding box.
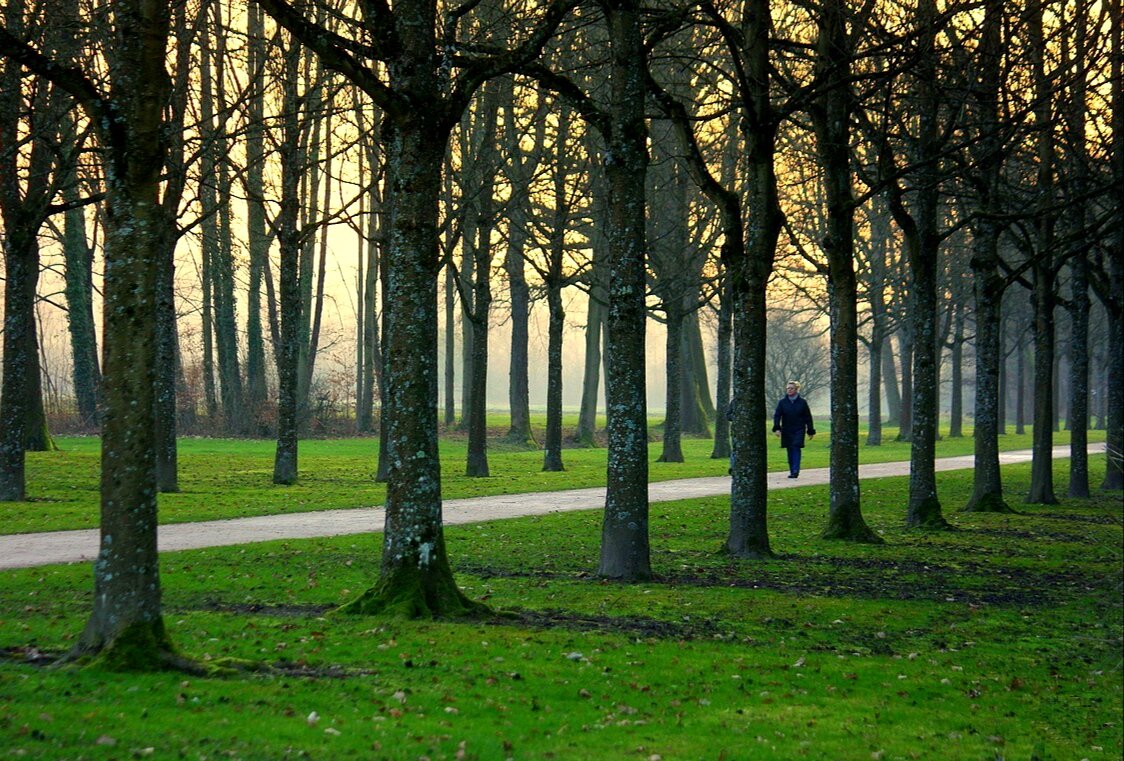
[0,426,1104,534]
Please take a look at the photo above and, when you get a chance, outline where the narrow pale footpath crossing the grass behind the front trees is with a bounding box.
[0,443,1105,570]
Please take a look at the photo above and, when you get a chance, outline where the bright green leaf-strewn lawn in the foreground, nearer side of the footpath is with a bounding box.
[0,455,1124,761]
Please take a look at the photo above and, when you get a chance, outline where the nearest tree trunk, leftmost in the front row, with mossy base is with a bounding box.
[67,1,175,671]
